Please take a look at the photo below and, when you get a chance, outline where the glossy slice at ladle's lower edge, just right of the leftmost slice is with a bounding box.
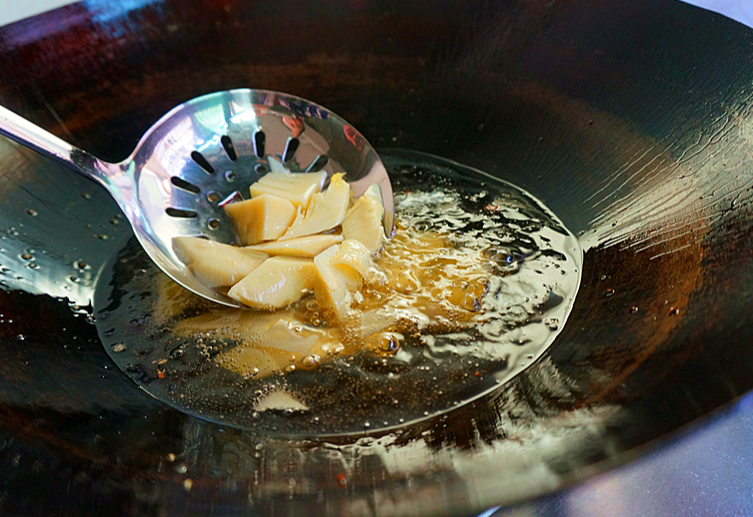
[227,256,316,309]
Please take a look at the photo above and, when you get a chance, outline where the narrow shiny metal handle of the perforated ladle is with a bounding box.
[0,106,107,183]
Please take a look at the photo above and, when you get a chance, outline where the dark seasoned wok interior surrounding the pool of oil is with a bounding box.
[0,0,753,515]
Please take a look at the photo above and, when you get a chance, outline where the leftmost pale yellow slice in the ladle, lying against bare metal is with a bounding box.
[173,237,267,287]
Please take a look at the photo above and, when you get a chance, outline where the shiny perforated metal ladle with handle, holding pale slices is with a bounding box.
[0,89,394,307]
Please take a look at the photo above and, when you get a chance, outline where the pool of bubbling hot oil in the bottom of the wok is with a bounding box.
[96,152,582,435]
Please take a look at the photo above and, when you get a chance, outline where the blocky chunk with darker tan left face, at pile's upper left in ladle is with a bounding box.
[225,194,297,244]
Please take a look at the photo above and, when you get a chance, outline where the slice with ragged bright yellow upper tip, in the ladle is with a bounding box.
[280,174,350,240]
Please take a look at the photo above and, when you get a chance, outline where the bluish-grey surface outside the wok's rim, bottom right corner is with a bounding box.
[485,393,753,517]
